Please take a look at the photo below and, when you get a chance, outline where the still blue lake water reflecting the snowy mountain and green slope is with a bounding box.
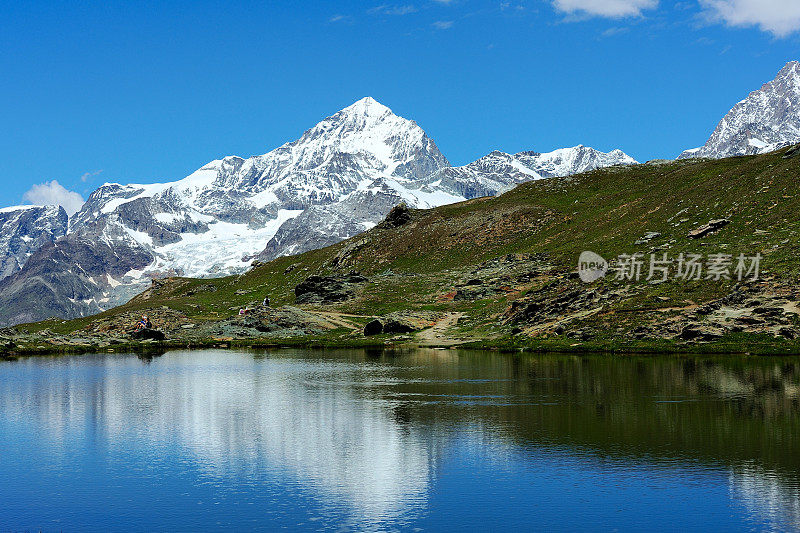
[0,350,800,532]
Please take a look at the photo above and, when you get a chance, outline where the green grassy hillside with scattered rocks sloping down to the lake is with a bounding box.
[7,145,800,351]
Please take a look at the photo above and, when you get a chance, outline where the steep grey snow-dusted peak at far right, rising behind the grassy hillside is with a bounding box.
[678,61,800,159]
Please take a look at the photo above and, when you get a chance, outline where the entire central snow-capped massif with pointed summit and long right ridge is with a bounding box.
[0,98,635,324]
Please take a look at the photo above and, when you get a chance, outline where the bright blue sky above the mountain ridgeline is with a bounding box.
[0,0,800,210]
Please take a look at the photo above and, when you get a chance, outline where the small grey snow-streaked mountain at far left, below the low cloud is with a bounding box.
[0,205,68,279]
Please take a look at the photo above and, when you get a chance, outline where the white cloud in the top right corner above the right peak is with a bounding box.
[700,0,800,37]
